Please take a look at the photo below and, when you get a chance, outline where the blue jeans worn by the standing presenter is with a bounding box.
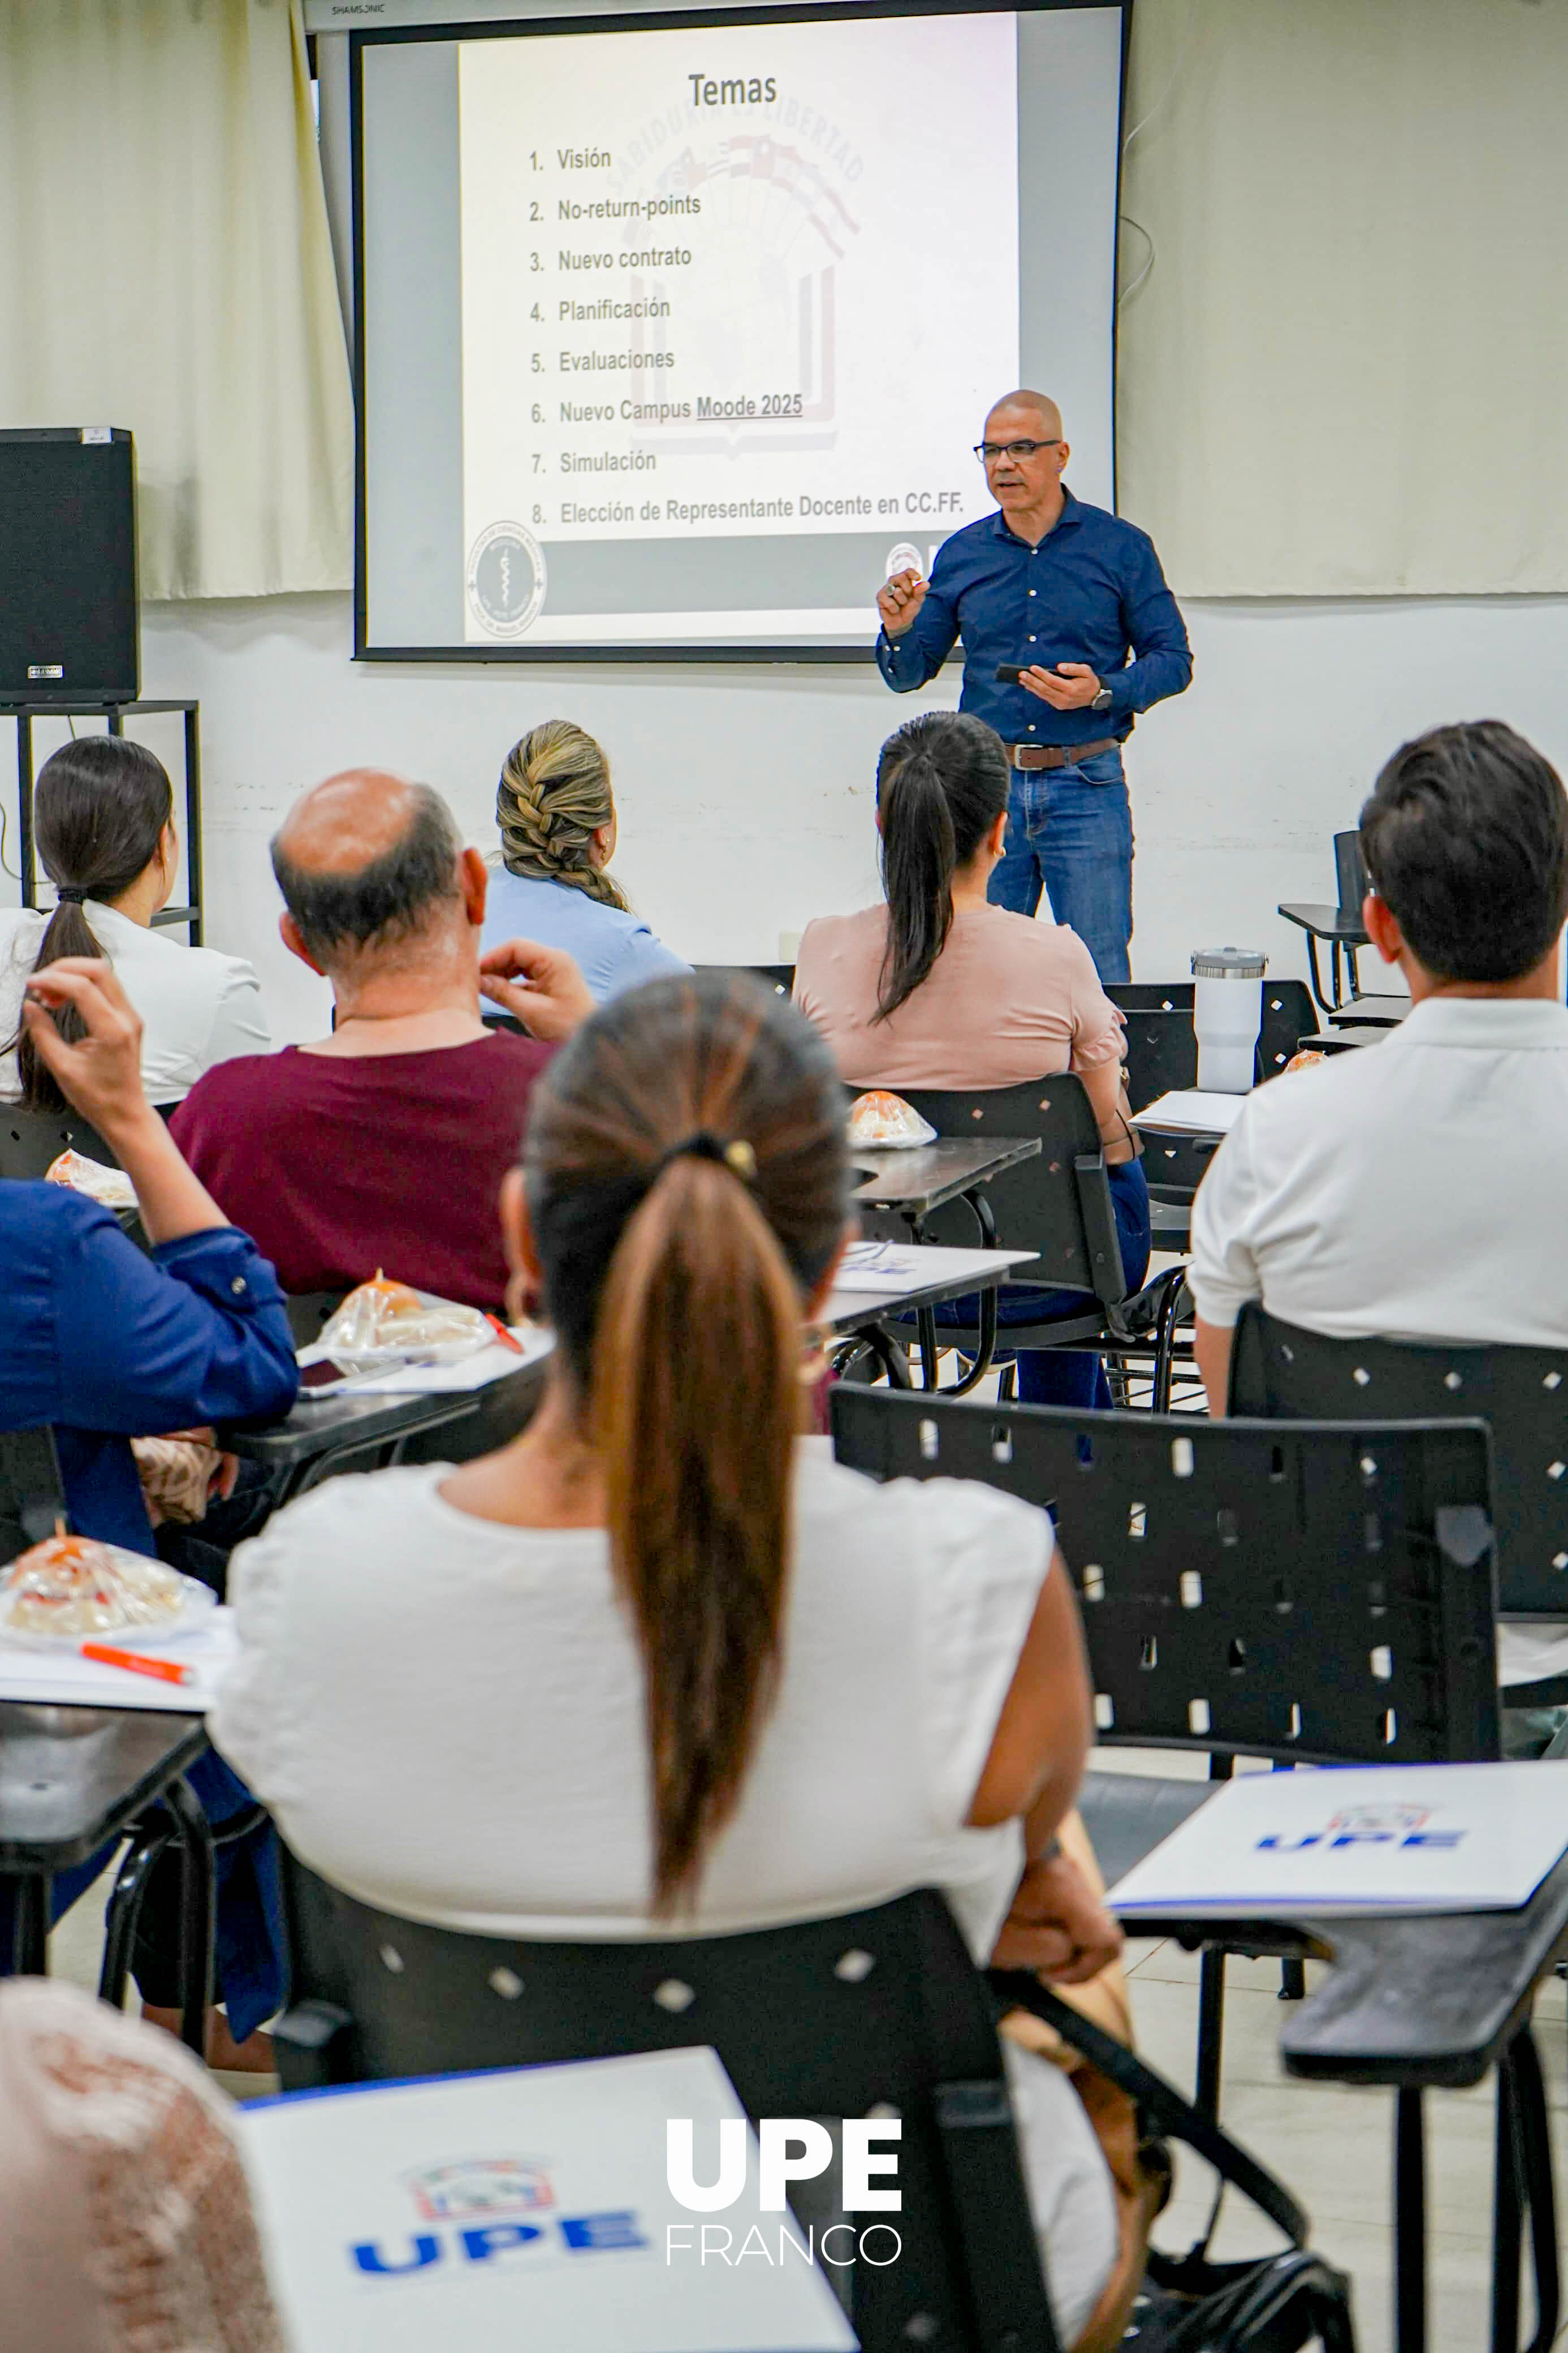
[990,751,1133,981]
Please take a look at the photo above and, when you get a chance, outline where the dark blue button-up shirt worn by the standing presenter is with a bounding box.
[877,487,1192,744]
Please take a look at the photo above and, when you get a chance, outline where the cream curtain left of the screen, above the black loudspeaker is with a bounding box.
[0,0,353,598]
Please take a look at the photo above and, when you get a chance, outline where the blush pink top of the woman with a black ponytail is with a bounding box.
[794,906,1126,1087]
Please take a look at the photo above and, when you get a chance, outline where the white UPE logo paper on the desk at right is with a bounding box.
[1107,1762,1568,1920]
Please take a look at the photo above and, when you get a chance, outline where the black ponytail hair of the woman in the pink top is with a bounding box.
[875,710,1009,1021]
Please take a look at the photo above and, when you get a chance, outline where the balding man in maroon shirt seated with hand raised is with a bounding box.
[171,769,593,1311]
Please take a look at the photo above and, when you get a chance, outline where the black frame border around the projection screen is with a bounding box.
[348,0,1133,666]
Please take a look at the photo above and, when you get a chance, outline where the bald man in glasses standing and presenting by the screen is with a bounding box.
[877,393,1192,981]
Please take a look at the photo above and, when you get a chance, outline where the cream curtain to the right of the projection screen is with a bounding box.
[1117,0,1568,597]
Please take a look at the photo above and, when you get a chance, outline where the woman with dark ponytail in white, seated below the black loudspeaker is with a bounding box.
[0,736,273,1111]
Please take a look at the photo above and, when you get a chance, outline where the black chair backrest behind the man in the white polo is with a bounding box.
[1229,1301,1568,1621]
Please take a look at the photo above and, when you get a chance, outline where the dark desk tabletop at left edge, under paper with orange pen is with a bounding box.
[0,1701,207,1871]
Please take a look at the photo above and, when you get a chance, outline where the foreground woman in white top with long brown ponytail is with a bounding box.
[211,974,1119,2343]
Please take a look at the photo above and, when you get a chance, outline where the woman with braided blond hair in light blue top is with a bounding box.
[482,720,689,1005]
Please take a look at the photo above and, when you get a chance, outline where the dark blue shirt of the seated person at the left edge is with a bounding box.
[0,1183,299,1553]
